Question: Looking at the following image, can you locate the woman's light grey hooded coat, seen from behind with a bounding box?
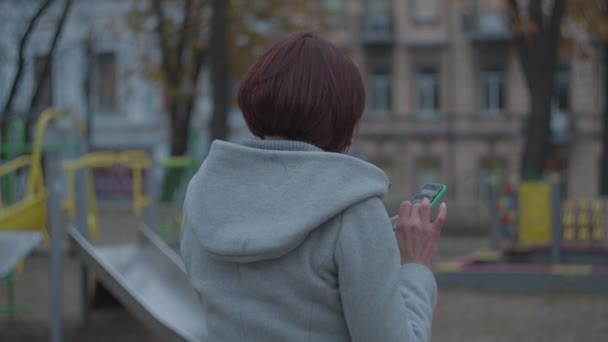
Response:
[181,139,437,342]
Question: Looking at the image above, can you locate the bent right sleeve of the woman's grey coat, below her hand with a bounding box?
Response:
[335,198,437,341]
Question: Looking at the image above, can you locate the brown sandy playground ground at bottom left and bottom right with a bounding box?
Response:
[0,204,608,342]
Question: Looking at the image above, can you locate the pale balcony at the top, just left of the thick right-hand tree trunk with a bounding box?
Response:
[462,2,513,43]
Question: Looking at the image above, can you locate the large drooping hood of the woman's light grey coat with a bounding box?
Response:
[183,139,388,262]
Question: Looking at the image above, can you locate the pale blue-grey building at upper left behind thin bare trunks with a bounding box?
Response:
[0,0,197,153]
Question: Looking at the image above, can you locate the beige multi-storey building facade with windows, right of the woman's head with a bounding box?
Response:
[328,0,603,210]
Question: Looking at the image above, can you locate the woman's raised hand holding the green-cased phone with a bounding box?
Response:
[391,198,448,267]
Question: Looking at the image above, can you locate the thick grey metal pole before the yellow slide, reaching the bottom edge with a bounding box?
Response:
[45,152,64,342]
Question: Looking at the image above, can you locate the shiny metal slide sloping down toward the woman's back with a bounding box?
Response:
[69,224,206,341]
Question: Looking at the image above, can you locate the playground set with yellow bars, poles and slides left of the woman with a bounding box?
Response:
[0,109,206,342]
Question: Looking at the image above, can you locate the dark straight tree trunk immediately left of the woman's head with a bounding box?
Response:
[210,0,230,142]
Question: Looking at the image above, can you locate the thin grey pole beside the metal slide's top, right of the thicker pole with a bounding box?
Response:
[75,168,91,324]
